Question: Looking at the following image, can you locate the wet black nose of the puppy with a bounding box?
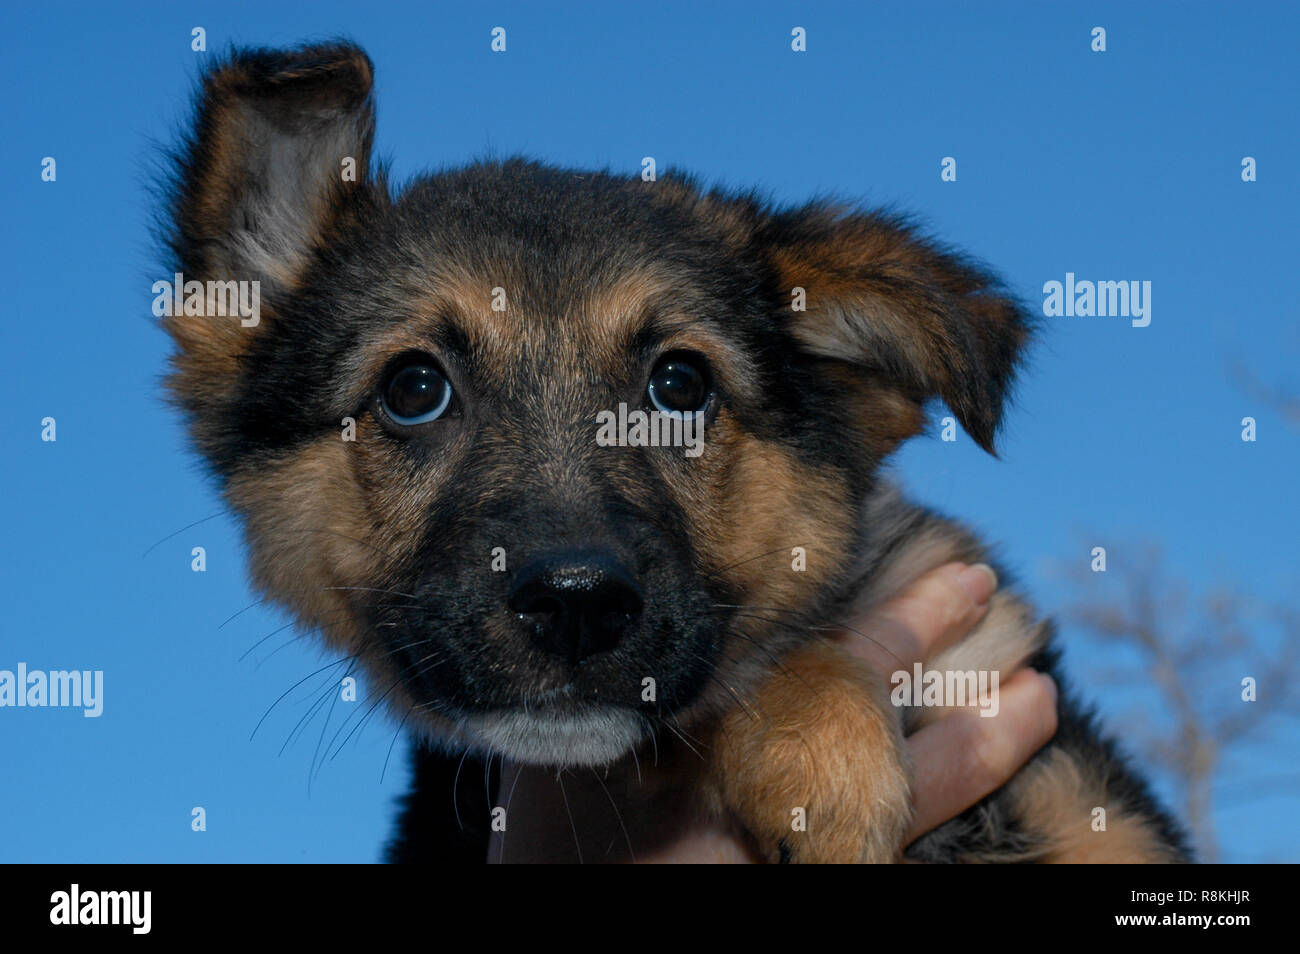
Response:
[506,550,644,663]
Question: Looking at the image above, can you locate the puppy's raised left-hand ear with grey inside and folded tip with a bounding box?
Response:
[164,43,374,409]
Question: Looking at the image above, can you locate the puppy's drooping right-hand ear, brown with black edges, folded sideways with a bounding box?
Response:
[759,204,1031,454]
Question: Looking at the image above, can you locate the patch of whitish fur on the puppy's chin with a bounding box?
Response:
[458,708,646,767]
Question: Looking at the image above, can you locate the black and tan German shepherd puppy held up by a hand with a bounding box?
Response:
[164,43,1187,862]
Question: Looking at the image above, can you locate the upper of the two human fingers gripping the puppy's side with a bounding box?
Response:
[836,563,997,675]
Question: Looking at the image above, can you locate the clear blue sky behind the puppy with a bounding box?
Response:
[0,0,1300,862]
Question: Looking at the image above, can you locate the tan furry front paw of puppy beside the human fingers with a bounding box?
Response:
[715,645,911,864]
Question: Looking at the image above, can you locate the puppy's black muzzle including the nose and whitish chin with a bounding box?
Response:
[379,561,729,767]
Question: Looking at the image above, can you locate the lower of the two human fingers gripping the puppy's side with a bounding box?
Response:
[907,669,1057,842]
